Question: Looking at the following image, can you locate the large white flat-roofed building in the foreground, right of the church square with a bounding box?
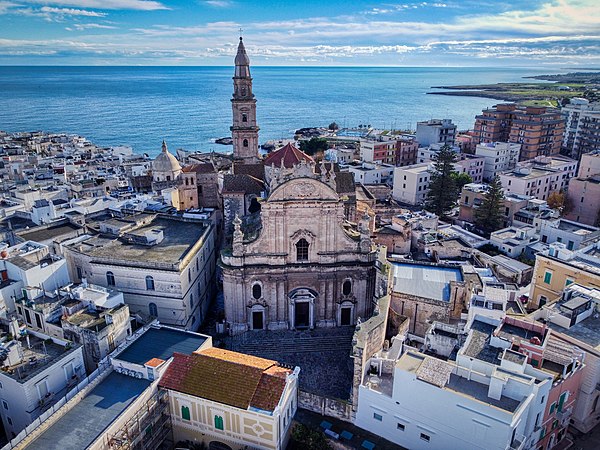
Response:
[355,351,539,450]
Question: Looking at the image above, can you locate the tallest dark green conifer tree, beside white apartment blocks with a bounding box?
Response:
[425,145,458,217]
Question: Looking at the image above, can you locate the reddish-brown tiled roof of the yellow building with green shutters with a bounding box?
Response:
[160,348,292,411]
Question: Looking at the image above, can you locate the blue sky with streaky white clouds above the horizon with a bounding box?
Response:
[0,0,600,68]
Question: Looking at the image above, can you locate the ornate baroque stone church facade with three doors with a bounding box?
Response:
[221,162,375,334]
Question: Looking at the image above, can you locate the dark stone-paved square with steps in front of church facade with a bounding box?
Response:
[222,327,354,400]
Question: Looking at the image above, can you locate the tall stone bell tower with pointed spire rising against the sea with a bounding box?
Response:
[231,36,260,164]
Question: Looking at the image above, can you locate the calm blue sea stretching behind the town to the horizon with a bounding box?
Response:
[0,67,552,156]
